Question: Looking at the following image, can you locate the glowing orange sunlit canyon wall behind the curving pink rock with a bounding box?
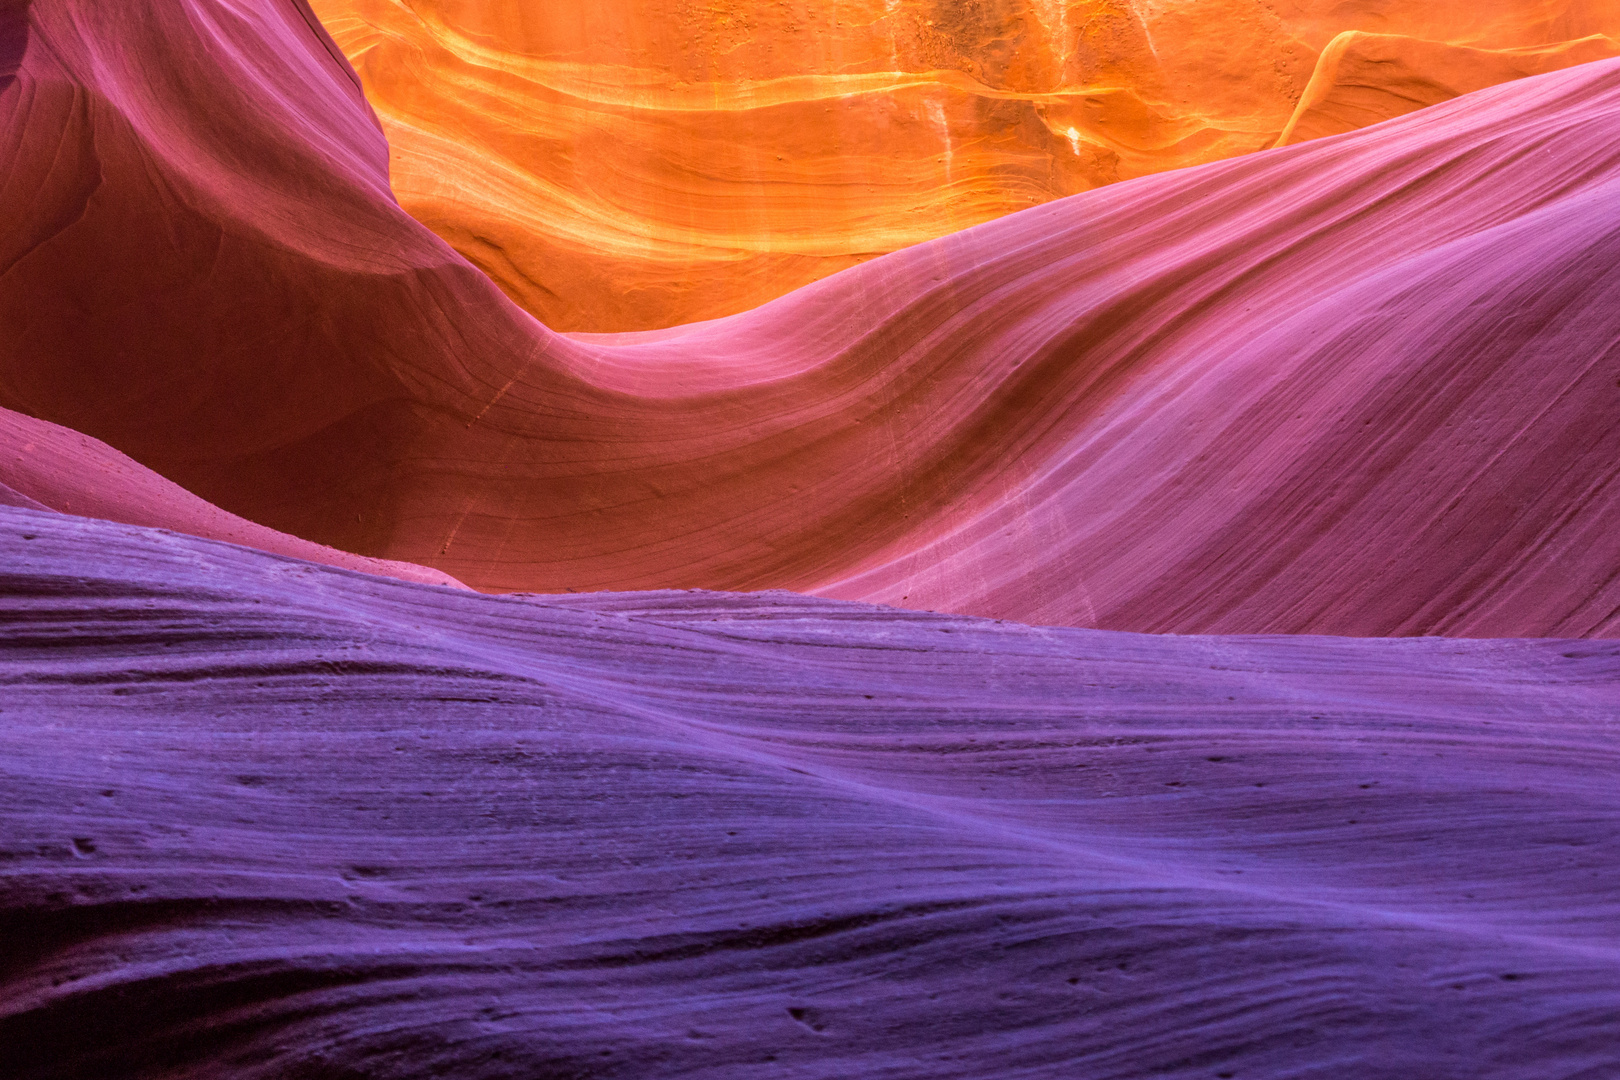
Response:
[313,0,1620,330]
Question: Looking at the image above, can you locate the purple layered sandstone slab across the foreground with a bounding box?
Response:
[0,508,1620,1080]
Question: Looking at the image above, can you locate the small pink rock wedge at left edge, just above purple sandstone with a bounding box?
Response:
[0,408,467,588]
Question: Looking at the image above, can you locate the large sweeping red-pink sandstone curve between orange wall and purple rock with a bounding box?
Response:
[0,0,1620,636]
